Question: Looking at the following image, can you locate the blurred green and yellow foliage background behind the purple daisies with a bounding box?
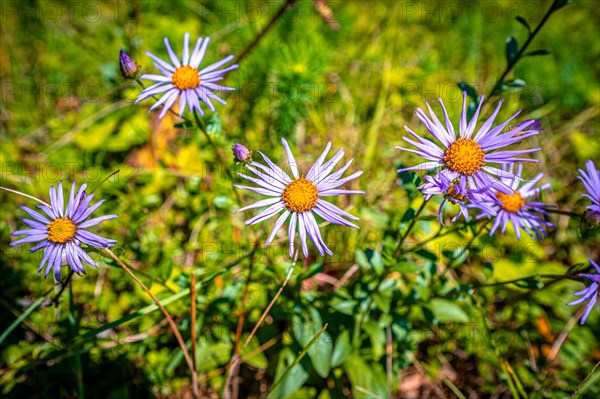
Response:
[0,0,600,399]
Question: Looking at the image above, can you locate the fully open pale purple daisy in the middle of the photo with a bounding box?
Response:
[236,138,365,257]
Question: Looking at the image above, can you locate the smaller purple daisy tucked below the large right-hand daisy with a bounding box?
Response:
[473,164,554,239]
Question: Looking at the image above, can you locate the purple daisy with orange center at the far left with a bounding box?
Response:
[10,182,117,281]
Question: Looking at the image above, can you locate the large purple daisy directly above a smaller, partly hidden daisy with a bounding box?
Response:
[396,92,540,194]
